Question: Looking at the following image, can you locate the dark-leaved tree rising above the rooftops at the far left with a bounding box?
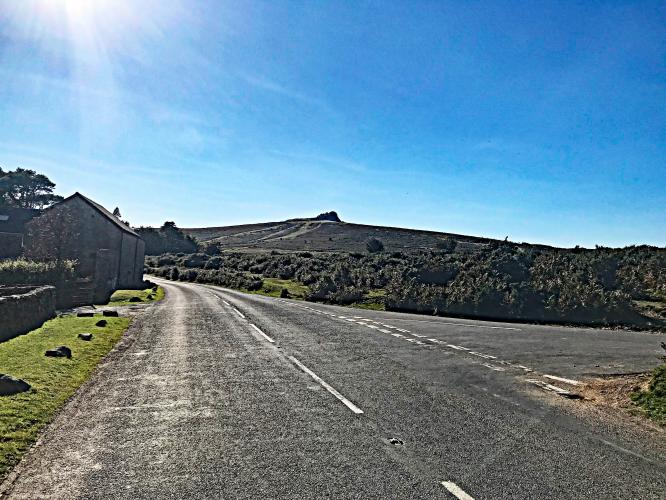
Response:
[0,168,63,209]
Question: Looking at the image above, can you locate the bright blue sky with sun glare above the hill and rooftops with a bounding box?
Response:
[0,0,666,246]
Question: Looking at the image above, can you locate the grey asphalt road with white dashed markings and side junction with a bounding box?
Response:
[0,281,666,500]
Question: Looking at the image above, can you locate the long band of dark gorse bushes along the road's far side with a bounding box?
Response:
[146,242,666,324]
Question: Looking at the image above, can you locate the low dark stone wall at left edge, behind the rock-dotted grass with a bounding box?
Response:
[0,286,56,342]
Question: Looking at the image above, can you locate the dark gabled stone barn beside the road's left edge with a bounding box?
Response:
[24,193,145,304]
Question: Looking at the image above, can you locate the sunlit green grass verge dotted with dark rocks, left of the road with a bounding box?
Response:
[0,316,130,476]
